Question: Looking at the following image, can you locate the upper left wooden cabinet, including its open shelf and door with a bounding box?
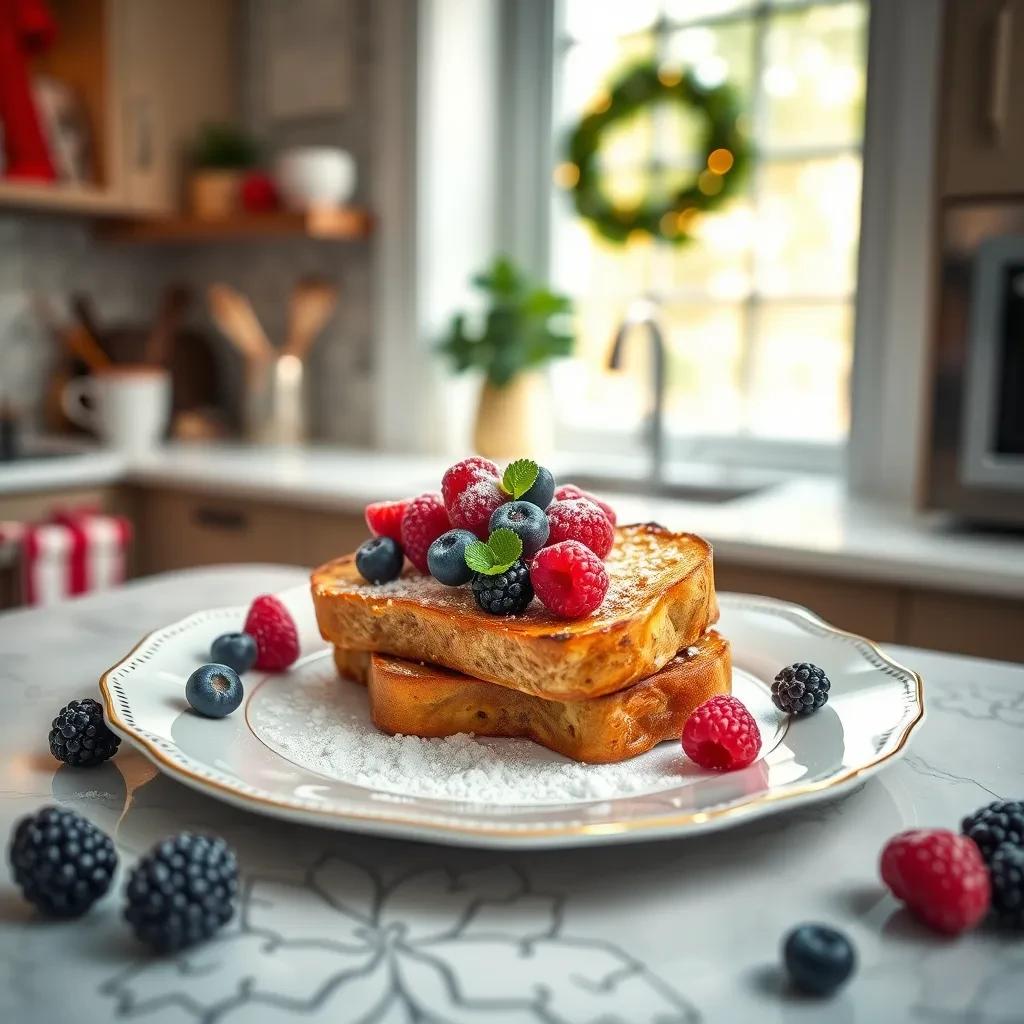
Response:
[0,0,238,216]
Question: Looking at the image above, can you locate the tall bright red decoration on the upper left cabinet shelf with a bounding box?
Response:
[0,0,57,181]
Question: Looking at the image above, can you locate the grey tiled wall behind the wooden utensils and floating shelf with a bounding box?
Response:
[0,0,378,445]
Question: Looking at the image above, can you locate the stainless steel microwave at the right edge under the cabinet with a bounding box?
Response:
[927,200,1024,526]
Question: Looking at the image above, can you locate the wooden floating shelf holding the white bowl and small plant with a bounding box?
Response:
[100,207,373,243]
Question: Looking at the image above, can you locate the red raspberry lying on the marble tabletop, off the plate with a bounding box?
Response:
[880,828,991,935]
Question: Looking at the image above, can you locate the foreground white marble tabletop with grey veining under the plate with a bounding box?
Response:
[0,566,1024,1024]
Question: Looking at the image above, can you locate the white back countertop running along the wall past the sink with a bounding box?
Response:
[0,445,1024,598]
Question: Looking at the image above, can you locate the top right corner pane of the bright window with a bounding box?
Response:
[762,3,866,150]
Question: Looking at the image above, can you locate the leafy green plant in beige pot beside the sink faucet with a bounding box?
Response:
[439,256,575,459]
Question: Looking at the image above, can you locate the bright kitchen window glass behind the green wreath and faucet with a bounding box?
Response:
[548,0,868,468]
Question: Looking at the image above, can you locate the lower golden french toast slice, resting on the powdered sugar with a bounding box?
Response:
[334,632,732,764]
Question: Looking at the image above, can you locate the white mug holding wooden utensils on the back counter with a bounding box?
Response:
[60,366,171,454]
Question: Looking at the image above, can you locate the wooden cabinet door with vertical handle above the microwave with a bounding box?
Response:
[939,0,1024,196]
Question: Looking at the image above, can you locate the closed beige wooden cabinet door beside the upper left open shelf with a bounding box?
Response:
[111,0,239,213]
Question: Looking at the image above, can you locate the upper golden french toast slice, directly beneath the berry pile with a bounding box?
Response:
[311,523,718,700]
